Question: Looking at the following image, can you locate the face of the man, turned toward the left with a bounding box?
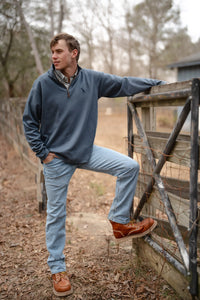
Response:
[51,40,77,71]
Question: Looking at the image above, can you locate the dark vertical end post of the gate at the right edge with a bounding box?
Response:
[189,79,200,296]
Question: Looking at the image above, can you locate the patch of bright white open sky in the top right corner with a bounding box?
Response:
[174,0,200,42]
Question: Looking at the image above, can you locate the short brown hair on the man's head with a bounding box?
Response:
[50,33,81,62]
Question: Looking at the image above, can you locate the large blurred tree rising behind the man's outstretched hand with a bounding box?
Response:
[127,0,180,77]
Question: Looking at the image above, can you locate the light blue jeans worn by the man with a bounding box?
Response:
[44,146,139,274]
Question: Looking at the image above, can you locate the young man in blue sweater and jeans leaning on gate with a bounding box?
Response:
[23,33,162,296]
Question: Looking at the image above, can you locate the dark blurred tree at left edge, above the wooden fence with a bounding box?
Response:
[0,0,33,97]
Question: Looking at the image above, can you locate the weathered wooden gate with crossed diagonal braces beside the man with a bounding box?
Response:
[127,78,200,299]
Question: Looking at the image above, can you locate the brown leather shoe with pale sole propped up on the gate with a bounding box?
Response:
[110,218,157,240]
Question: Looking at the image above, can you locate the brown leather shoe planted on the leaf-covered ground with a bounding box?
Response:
[52,272,73,297]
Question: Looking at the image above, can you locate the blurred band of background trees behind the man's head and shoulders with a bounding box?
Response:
[0,0,200,97]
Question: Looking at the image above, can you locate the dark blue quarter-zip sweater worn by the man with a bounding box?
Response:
[23,65,163,164]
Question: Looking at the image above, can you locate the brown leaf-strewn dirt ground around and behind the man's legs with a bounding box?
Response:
[0,105,180,300]
